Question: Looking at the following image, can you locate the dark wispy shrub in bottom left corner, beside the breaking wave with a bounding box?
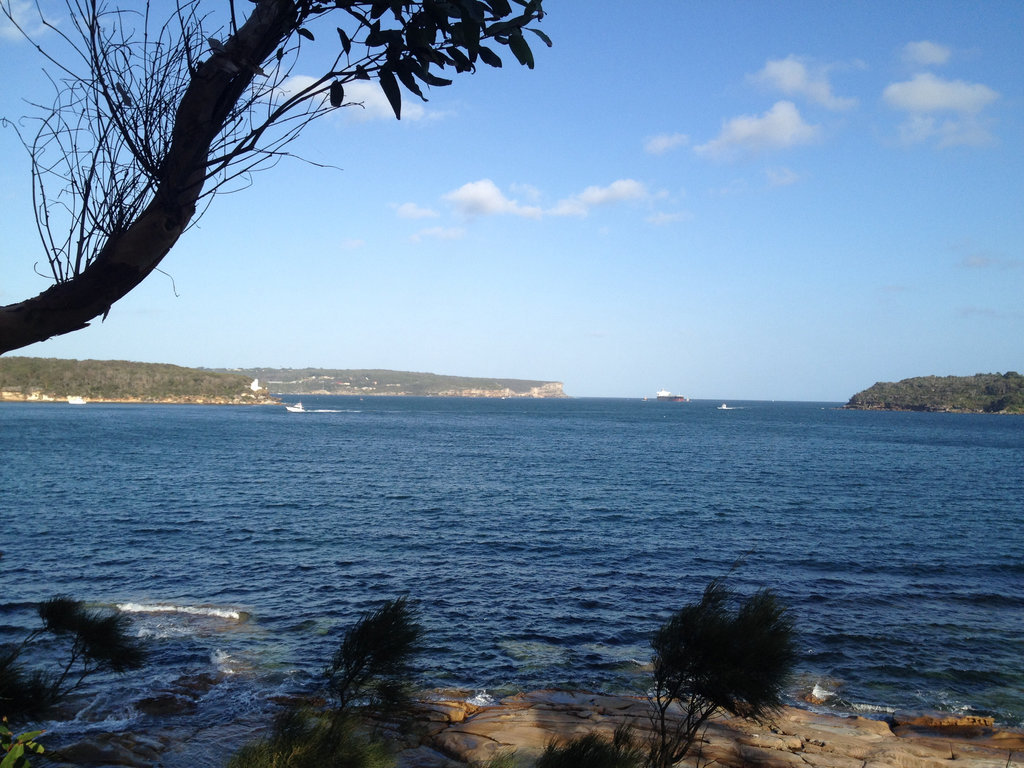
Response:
[0,595,144,721]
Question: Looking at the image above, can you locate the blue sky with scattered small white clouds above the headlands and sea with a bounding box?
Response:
[0,0,1024,400]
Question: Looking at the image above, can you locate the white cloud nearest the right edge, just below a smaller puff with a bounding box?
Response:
[882,72,999,147]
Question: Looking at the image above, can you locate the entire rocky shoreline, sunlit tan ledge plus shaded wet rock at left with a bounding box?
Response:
[44,690,1024,768]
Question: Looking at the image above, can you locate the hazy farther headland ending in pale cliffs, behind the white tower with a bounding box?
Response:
[215,368,566,397]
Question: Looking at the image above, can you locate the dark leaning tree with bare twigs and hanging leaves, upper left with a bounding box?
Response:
[0,0,551,353]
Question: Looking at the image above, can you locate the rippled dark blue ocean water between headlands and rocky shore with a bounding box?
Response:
[0,397,1024,753]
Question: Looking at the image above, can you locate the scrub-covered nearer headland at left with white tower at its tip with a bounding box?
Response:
[0,357,275,404]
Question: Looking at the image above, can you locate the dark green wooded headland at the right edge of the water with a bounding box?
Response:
[845,371,1024,414]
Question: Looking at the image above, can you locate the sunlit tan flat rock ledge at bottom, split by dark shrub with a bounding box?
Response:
[398,690,1024,768]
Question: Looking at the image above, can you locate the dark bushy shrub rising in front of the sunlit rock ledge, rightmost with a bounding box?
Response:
[649,580,796,768]
